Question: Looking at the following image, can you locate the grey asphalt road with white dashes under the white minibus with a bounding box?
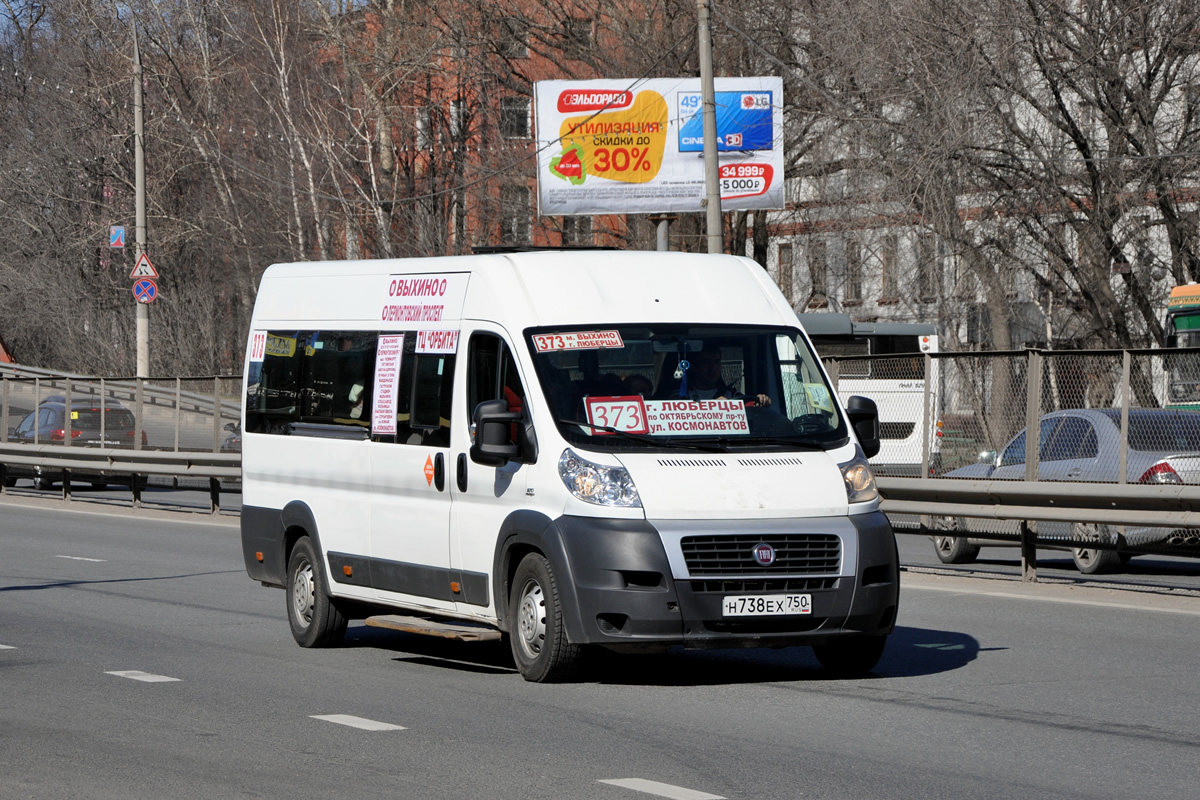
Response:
[0,498,1200,800]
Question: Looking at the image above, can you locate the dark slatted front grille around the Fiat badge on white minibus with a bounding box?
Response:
[679,534,841,577]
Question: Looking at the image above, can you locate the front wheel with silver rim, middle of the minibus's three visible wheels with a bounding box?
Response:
[509,553,580,682]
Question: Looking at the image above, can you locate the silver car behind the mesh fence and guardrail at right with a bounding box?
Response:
[932,409,1200,575]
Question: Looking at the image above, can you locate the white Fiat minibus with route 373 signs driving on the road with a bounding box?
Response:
[241,249,899,681]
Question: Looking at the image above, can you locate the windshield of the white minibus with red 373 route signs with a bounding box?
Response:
[526,324,848,451]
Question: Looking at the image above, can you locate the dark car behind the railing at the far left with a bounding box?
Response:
[5,395,148,489]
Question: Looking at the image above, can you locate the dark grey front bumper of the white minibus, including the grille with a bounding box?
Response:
[552,512,900,649]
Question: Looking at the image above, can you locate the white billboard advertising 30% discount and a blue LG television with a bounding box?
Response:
[534,77,784,216]
